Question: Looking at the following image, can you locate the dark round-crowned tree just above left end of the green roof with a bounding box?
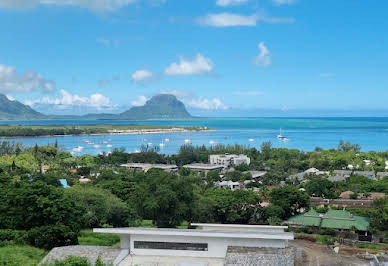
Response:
[269,186,310,219]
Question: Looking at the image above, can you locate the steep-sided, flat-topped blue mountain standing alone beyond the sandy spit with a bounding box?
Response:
[118,94,192,120]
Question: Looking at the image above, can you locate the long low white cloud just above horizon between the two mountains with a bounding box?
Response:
[24,90,113,110]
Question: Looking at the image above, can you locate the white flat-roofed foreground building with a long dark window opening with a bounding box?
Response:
[93,224,294,266]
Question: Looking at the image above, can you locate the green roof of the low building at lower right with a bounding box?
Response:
[287,209,370,231]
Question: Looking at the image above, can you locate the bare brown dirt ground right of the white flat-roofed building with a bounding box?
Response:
[289,240,370,266]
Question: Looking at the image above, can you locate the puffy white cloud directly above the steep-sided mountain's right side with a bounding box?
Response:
[164,54,214,76]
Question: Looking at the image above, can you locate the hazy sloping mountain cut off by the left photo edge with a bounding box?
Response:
[0,93,46,120]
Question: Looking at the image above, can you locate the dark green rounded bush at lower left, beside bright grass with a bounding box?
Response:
[28,224,78,250]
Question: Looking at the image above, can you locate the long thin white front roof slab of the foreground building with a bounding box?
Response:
[93,227,294,240]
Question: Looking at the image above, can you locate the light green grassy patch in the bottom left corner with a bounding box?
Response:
[0,245,47,266]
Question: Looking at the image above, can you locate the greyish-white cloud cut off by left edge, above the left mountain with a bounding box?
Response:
[0,64,55,93]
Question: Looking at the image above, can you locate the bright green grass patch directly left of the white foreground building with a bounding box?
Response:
[78,229,120,247]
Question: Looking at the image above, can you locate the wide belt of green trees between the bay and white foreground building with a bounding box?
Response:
[0,139,388,264]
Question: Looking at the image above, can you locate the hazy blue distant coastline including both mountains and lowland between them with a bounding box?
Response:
[0,94,192,120]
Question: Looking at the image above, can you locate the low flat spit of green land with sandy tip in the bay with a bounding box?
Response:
[0,125,211,137]
